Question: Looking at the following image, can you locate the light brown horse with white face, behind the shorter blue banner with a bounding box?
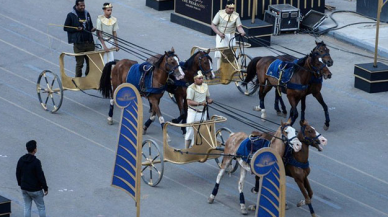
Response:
[208,122,302,215]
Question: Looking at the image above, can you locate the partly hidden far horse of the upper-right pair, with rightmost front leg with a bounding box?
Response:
[275,54,332,130]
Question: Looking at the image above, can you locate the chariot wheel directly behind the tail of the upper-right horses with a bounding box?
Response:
[234,54,259,96]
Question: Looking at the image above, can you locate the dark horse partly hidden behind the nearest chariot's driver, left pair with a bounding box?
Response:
[147,49,215,134]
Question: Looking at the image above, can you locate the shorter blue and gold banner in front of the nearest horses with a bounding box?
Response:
[251,148,286,217]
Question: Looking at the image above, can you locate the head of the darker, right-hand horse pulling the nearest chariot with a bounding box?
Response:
[300,121,327,151]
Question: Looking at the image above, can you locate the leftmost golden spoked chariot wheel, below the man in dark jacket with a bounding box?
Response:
[36,70,63,113]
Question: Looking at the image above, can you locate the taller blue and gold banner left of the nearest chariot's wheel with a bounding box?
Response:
[112,83,143,215]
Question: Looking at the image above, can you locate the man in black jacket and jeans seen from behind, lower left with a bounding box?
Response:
[16,140,48,217]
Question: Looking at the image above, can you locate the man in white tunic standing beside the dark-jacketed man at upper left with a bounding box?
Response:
[96,3,119,63]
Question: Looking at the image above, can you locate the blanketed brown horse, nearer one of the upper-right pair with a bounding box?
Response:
[243,42,333,124]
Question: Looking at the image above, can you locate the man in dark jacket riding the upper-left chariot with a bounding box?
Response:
[63,0,96,77]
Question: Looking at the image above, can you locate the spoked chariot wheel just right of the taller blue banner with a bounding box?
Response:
[141,139,164,187]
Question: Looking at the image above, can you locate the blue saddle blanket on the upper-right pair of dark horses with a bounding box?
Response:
[266,59,298,84]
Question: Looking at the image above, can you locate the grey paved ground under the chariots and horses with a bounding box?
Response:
[0,0,388,217]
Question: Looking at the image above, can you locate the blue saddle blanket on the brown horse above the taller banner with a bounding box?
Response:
[127,62,166,93]
